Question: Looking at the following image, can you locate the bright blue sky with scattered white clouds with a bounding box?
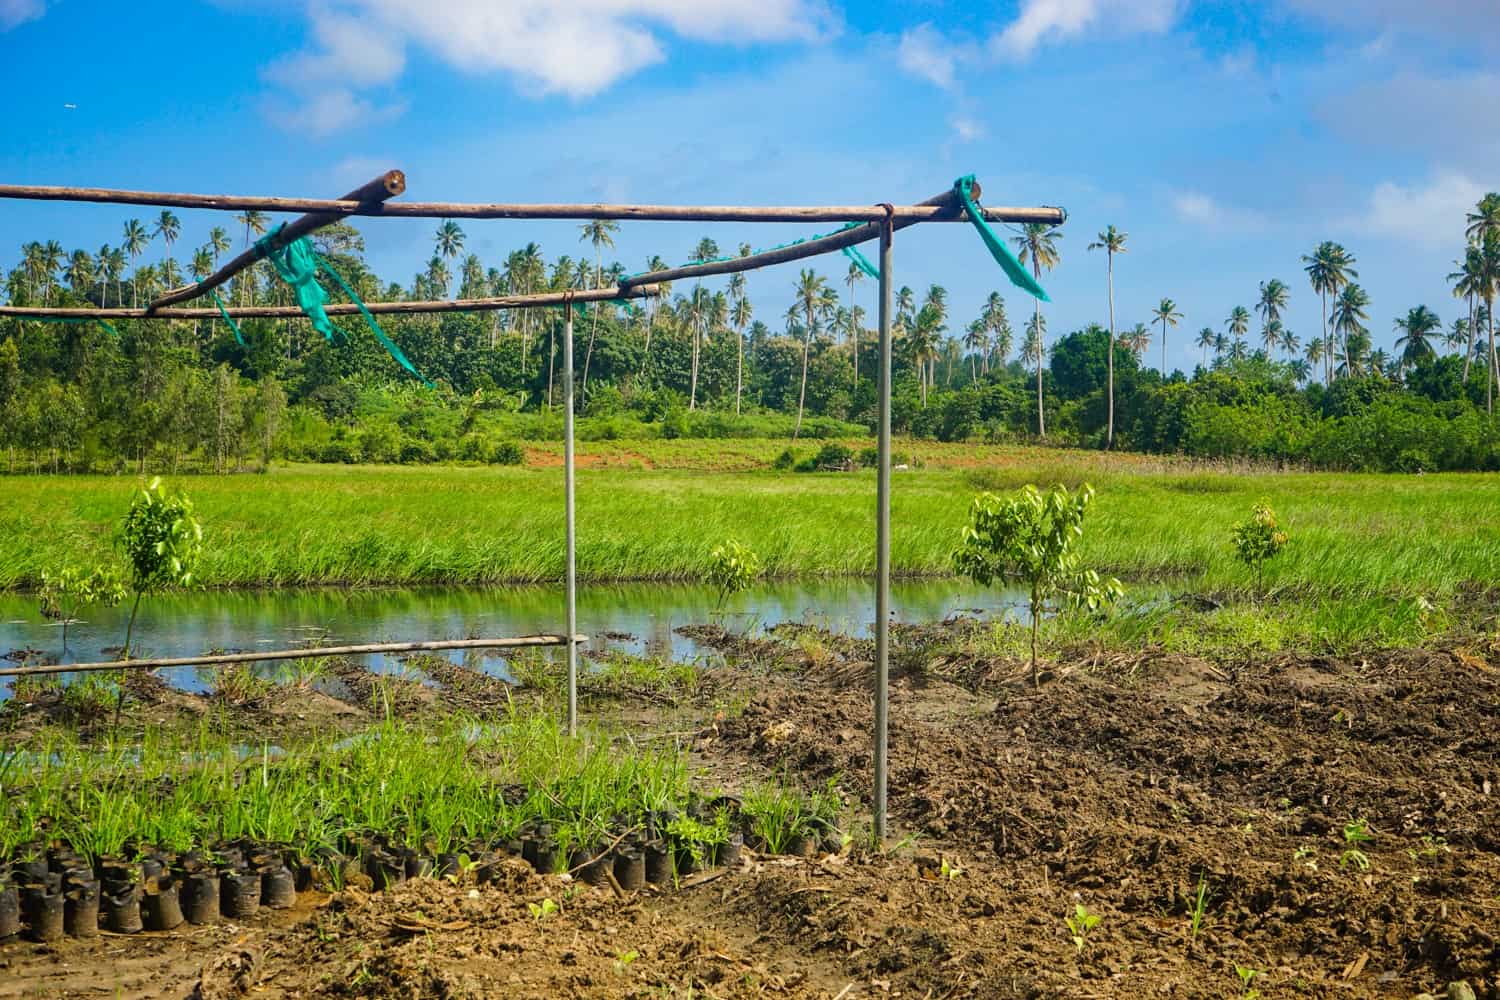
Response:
[0,0,1500,366]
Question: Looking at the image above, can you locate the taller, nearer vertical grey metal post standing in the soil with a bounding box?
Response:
[875,212,896,846]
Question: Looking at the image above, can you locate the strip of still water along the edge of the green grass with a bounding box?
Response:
[0,579,1023,699]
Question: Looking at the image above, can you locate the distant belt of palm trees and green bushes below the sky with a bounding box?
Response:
[0,195,1500,472]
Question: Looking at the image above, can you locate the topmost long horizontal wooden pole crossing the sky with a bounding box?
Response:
[0,184,1068,225]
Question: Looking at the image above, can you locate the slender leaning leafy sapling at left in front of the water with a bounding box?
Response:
[119,477,203,660]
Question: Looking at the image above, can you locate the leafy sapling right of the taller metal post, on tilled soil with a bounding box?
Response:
[953,484,1124,685]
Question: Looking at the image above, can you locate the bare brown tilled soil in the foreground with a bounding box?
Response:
[0,622,1500,1000]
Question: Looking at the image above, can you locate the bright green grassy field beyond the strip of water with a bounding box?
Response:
[0,442,1500,597]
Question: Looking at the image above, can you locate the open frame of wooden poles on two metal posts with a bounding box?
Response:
[0,169,1068,840]
